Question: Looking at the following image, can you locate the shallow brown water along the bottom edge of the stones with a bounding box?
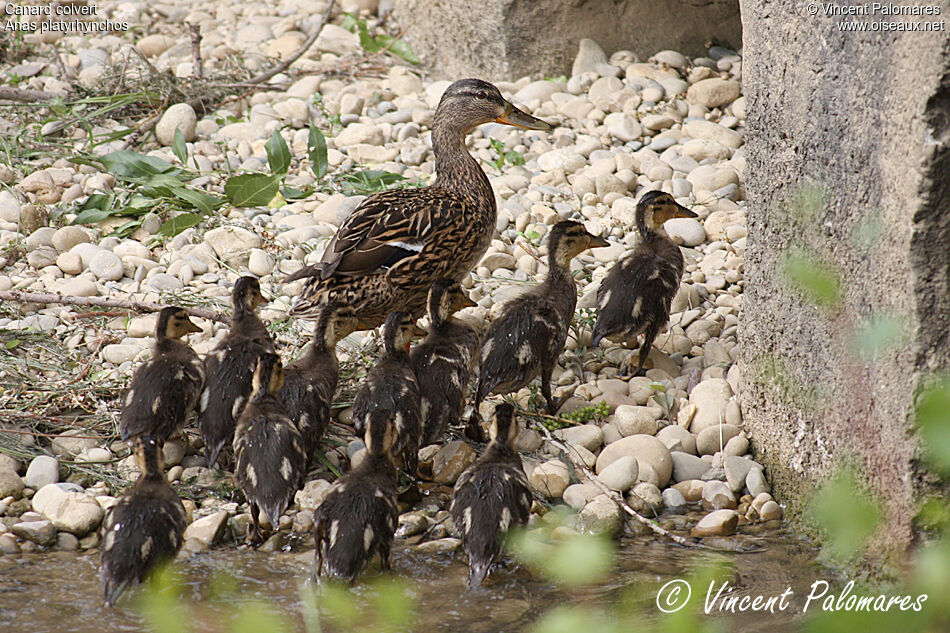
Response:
[0,530,832,633]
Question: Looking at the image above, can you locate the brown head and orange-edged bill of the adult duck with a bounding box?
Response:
[433,79,554,134]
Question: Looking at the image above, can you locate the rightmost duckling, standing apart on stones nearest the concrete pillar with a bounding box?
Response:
[591,191,696,376]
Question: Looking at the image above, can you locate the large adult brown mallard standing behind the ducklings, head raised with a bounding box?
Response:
[288,79,552,329]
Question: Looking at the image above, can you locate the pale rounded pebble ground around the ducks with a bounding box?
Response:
[0,0,781,554]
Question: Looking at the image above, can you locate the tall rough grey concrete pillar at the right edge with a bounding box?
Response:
[740,0,950,558]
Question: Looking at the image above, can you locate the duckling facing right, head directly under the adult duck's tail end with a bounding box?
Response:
[277,304,357,458]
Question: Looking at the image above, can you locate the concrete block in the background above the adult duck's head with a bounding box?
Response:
[395,0,741,80]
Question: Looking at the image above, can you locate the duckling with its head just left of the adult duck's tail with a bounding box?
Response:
[198,277,274,468]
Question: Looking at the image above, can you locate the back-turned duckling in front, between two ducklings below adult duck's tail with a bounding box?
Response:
[234,354,307,543]
